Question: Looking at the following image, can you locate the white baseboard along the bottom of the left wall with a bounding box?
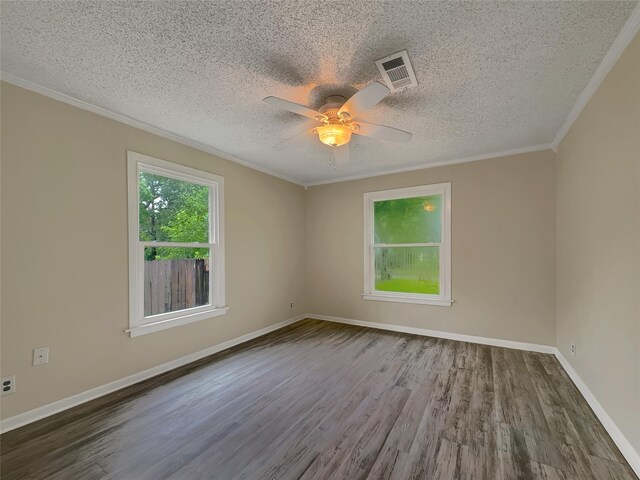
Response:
[0,315,306,433]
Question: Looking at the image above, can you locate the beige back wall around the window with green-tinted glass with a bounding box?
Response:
[307,150,555,345]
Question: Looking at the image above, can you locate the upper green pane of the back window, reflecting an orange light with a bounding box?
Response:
[373,195,442,244]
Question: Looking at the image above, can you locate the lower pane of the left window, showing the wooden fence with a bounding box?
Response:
[144,247,210,317]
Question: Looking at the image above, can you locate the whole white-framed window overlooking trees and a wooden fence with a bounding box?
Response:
[127,152,227,337]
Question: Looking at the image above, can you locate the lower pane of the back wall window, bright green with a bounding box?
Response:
[375,247,440,295]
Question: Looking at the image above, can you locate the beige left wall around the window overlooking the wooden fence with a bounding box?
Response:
[1,83,305,418]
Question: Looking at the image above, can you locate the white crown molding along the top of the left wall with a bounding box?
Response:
[0,72,305,186]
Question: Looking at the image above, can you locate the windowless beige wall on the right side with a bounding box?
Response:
[557,31,640,452]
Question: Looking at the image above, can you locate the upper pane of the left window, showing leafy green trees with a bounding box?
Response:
[138,172,209,243]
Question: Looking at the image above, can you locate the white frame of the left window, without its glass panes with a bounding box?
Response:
[126,151,228,337]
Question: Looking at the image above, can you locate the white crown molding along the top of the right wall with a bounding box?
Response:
[551,3,640,151]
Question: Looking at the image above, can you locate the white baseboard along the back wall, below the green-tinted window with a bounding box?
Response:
[307,313,556,353]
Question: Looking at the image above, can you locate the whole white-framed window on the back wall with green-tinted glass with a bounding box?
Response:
[363,183,451,305]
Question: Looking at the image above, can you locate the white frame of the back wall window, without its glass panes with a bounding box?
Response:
[362,182,453,306]
